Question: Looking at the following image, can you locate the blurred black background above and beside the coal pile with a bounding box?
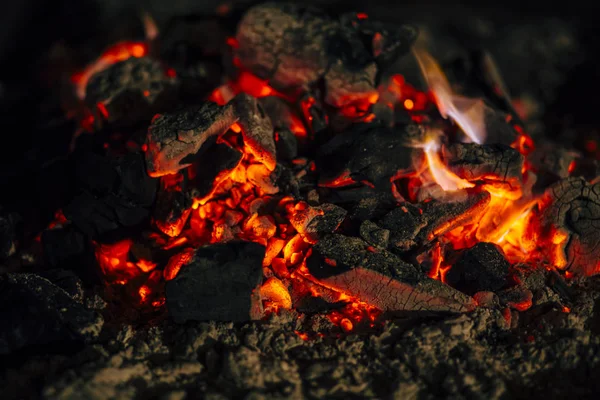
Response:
[0,0,600,225]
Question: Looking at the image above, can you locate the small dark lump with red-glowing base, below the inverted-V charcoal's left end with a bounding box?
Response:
[152,187,193,237]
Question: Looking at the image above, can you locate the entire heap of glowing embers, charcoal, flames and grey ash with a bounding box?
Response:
[0,3,600,399]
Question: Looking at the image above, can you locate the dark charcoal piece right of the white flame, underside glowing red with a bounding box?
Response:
[443,143,525,190]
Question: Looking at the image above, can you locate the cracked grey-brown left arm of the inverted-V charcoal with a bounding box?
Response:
[146,102,237,177]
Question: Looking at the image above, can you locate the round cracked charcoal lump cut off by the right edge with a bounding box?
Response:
[539,178,600,276]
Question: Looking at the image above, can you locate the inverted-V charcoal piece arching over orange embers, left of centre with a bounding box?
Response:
[146,94,276,177]
